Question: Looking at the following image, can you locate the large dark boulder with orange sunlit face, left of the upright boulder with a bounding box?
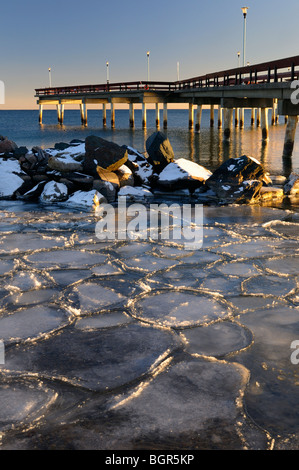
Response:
[83,135,128,175]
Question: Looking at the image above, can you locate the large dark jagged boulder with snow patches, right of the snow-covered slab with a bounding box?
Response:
[206,155,271,193]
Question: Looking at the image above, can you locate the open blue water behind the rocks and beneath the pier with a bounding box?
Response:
[0,109,299,176]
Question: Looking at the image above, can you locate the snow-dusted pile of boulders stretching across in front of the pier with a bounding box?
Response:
[0,132,299,207]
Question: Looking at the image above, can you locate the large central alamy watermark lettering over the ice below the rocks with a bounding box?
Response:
[95,197,203,250]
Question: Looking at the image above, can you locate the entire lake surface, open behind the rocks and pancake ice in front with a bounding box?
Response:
[0,110,299,451]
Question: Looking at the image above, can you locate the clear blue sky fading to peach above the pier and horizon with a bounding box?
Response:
[0,0,299,109]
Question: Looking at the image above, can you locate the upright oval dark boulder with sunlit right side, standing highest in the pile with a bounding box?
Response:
[146,131,174,173]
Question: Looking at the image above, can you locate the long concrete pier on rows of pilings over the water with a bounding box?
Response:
[35,56,299,157]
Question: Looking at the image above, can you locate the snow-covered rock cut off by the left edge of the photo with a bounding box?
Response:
[0,158,24,199]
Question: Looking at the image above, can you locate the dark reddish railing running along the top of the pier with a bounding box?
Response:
[35,56,299,97]
